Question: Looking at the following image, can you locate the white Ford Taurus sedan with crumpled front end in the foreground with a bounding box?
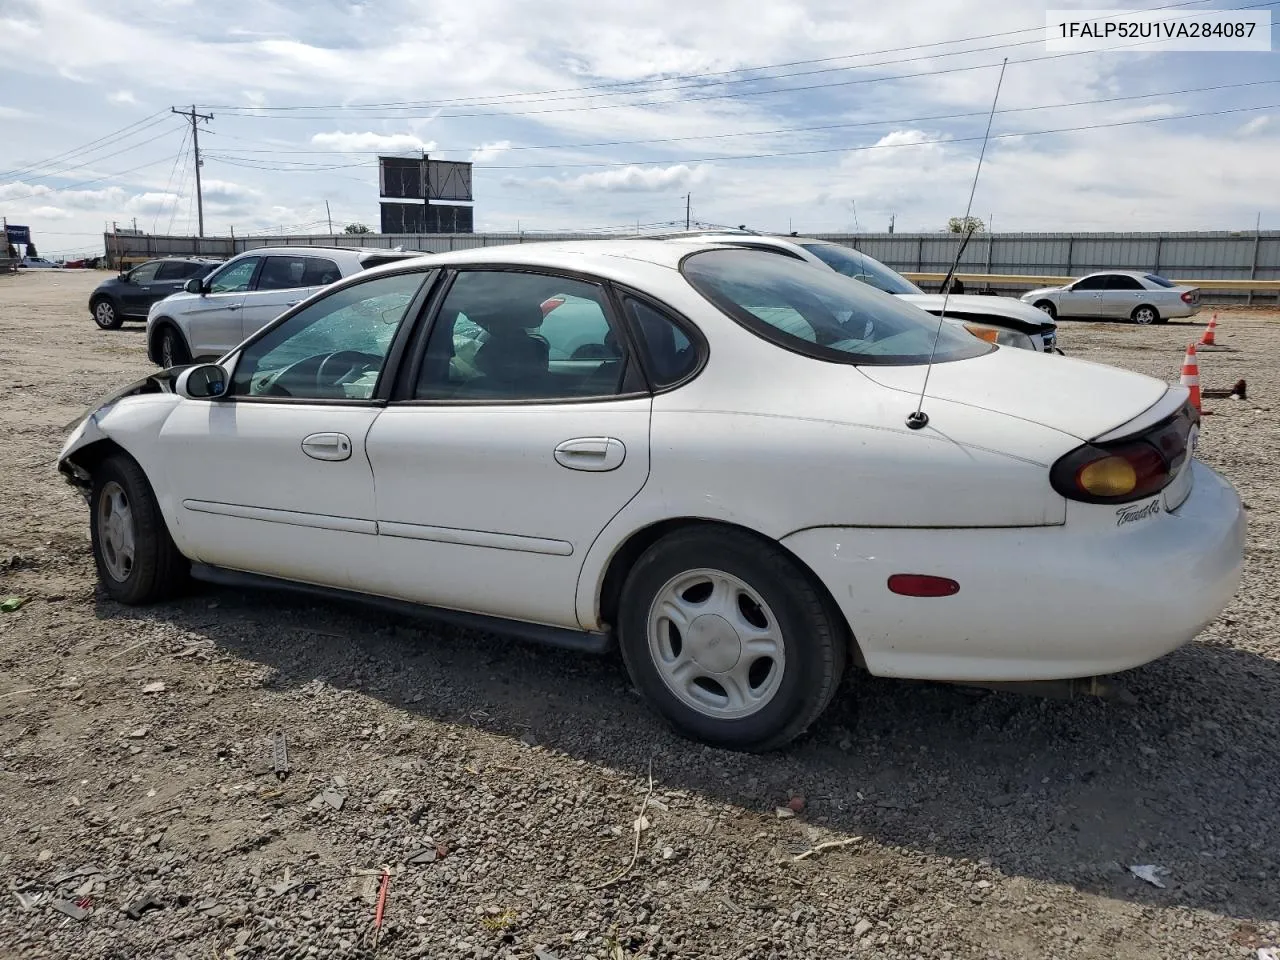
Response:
[59,239,1244,750]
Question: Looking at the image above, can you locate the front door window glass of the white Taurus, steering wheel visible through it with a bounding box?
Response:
[230,273,428,399]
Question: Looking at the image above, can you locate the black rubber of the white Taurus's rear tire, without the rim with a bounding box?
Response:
[618,529,850,753]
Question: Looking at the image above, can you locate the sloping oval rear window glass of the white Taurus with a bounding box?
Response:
[680,250,993,366]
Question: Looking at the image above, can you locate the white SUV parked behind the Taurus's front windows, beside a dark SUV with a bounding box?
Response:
[147,247,420,367]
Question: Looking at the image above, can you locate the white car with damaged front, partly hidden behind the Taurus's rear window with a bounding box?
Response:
[671,233,1061,353]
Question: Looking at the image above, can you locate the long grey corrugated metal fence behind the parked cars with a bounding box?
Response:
[104,230,1280,298]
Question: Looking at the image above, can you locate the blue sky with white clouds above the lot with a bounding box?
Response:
[0,0,1280,255]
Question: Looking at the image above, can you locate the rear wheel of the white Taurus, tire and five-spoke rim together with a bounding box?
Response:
[618,529,847,751]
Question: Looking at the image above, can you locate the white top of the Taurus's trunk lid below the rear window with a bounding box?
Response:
[858,347,1169,440]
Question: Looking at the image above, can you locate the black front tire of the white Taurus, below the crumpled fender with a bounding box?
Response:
[90,453,191,605]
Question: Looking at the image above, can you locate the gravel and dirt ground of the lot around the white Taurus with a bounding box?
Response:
[0,273,1280,960]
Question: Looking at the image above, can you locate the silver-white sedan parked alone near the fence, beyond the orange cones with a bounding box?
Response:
[1021,270,1201,325]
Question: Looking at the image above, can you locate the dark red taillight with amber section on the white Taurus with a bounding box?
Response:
[1048,406,1197,503]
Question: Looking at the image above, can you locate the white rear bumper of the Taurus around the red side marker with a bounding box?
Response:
[783,462,1244,681]
